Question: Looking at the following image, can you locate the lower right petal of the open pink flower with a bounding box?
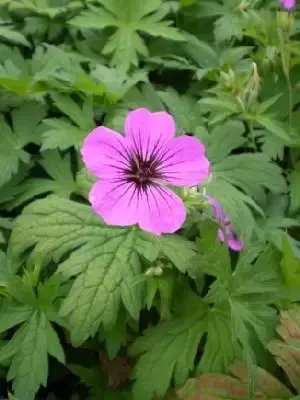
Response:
[139,186,186,235]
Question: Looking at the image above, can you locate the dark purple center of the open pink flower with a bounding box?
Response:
[126,155,161,187]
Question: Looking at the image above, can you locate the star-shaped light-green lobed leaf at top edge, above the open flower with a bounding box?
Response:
[70,0,185,71]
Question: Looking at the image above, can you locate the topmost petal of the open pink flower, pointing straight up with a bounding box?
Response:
[125,108,176,159]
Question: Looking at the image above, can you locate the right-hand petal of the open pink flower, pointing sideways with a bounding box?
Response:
[159,136,210,186]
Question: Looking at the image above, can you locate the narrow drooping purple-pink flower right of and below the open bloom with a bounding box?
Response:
[207,196,244,251]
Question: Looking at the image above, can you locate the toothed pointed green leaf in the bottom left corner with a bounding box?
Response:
[0,311,64,400]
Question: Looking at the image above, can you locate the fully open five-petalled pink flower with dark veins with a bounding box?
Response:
[81,108,210,235]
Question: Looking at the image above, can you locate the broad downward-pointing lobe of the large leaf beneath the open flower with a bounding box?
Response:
[58,230,142,343]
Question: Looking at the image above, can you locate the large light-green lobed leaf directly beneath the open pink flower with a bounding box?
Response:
[10,196,142,343]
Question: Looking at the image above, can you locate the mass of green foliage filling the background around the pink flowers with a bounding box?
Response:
[0,0,300,400]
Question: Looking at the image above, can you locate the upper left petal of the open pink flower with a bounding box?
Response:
[81,126,129,178]
